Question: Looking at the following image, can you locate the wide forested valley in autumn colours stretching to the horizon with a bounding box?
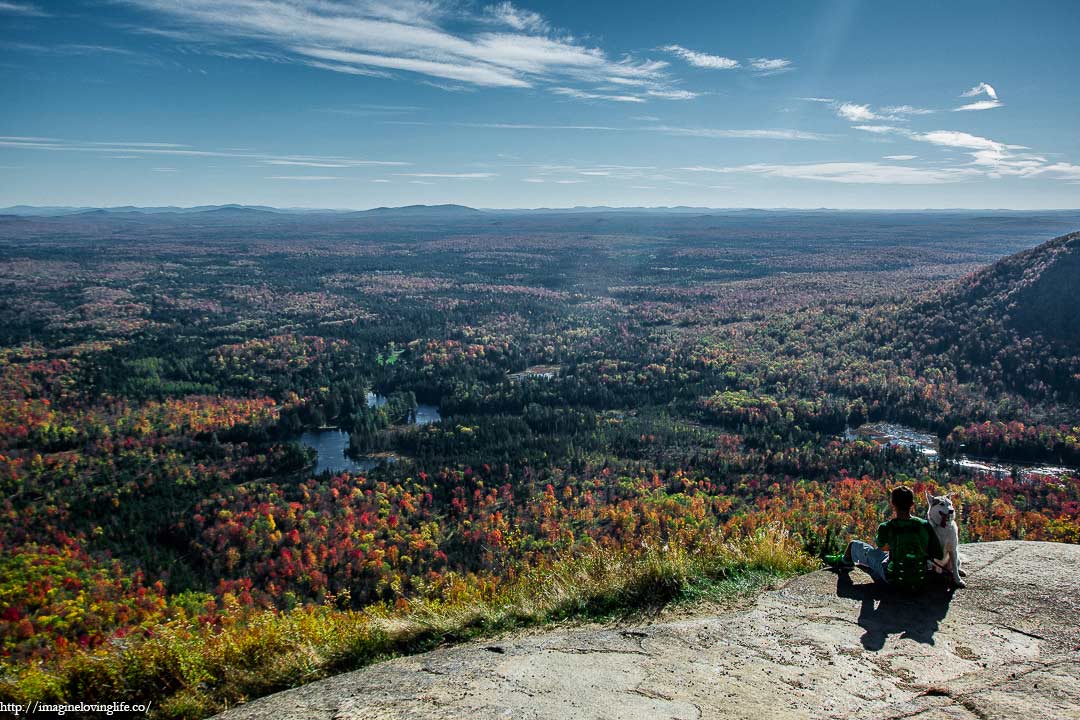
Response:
[0,208,1080,718]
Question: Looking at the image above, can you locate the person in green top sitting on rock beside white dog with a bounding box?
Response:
[825,487,945,589]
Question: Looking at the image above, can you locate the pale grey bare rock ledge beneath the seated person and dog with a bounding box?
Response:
[218,542,1080,720]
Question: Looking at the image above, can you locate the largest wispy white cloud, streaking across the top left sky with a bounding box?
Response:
[118,0,678,101]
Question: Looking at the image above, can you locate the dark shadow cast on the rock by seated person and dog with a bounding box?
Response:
[836,571,953,651]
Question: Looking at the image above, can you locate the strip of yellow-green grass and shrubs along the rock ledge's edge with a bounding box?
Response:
[0,526,819,720]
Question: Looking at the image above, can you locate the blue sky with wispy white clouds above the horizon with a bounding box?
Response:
[0,0,1080,208]
